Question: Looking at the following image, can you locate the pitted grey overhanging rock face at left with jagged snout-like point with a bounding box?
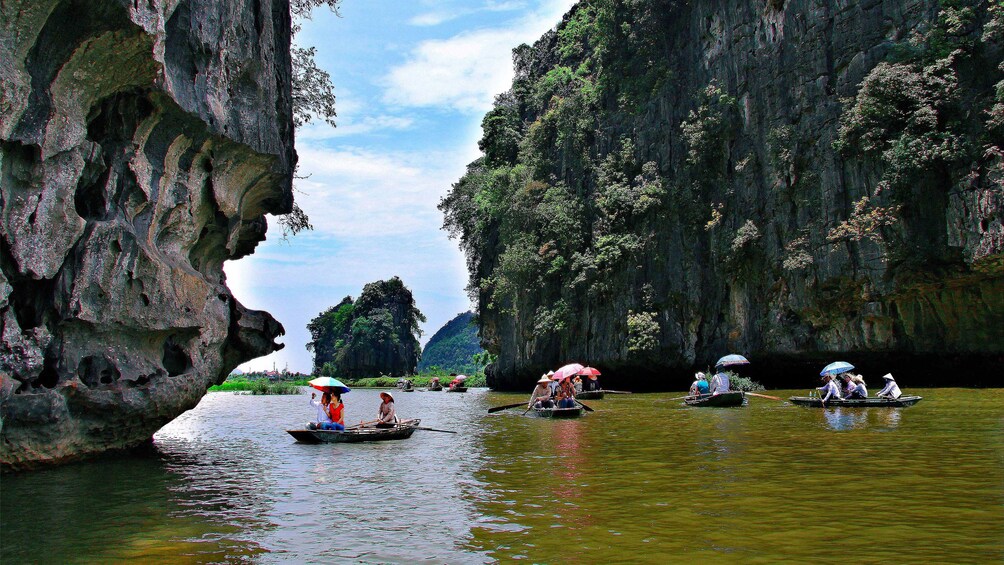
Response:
[0,0,295,469]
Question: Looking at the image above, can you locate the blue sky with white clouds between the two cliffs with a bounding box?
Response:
[225,0,574,372]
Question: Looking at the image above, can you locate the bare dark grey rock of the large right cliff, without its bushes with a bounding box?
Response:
[467,0,1004,389]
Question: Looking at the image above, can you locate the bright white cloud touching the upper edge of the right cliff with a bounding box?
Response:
[384,0,575,113]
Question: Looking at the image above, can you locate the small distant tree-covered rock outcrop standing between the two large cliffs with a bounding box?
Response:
[307,277,426,378]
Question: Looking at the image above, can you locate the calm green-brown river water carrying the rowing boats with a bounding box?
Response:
[0,388,1004,563]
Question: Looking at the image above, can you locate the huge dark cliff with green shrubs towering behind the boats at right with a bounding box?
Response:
[441,0,1004,388]
